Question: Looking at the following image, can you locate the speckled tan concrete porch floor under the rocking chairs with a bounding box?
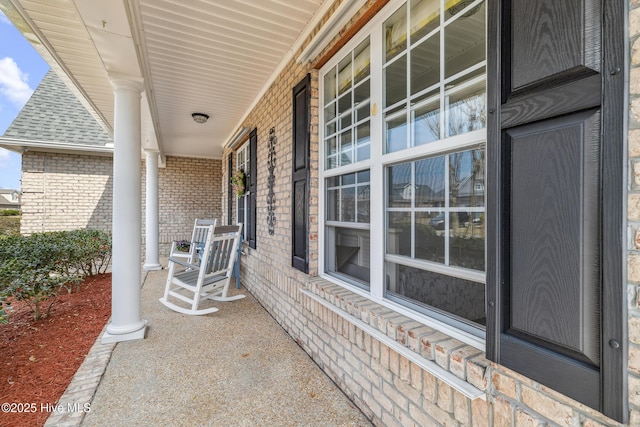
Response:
[46,270,371,426]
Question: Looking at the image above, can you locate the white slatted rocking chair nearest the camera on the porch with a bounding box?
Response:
[160,224,245,315]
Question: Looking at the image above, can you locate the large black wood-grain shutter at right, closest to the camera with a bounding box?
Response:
[487,0,628,422]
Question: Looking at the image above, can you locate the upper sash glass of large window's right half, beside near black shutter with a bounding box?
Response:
[383,0,486,153]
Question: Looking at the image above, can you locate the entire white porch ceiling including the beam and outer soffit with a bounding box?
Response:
[5,0,336,158]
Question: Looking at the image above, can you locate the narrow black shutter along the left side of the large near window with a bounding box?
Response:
[291,74,311,273]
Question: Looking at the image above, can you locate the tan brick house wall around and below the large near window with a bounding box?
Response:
[223,0,640,427]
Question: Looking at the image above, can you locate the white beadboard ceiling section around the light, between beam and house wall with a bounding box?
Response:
[130,0,323,158]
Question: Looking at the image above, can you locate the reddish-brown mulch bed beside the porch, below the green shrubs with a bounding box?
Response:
[0,274,111,427]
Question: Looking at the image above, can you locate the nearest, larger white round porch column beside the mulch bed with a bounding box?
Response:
[102,75,147,343]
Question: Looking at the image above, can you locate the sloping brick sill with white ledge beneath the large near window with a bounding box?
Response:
[301,278,490,400]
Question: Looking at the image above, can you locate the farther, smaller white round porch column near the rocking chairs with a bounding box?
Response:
[143,150,162,271]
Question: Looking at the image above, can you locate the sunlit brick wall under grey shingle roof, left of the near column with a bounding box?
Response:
[20,151,113,234]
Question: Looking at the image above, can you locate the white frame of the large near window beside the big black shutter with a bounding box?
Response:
[318,0,487,351]
